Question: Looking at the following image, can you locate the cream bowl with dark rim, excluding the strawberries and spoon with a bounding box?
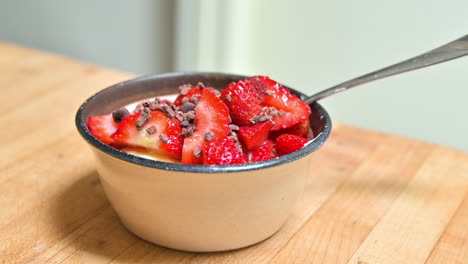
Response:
[76,73,331,252]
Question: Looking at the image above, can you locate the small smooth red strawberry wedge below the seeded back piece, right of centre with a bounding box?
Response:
[239,121,273,150]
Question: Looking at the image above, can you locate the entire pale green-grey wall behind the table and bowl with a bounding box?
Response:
[0,0,468,151]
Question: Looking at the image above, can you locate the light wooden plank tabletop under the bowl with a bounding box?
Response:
[0,43,468,264]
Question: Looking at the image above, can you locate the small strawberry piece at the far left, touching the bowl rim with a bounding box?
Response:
[87,114,118,146]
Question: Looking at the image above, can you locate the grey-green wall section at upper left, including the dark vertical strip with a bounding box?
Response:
[0,0,174,74]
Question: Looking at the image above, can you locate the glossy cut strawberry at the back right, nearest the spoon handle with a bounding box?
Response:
[258,76,311,130]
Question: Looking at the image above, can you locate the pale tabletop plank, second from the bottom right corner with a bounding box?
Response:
[348,147,468,264]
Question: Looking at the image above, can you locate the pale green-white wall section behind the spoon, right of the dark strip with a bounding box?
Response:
[178,0,468,150]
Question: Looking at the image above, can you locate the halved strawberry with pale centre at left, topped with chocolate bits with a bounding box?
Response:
[112,111,182,159]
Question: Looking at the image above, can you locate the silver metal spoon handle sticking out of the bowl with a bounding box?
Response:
[304,35,468,104]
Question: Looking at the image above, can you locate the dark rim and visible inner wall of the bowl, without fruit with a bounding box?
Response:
[75,73,331,172]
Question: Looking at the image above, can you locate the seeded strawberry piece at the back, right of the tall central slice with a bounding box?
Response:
[221,77,266,126]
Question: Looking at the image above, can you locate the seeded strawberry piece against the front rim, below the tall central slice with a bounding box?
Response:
[203,138,247,165]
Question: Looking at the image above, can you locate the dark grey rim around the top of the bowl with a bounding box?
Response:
[75,72,332,173]
